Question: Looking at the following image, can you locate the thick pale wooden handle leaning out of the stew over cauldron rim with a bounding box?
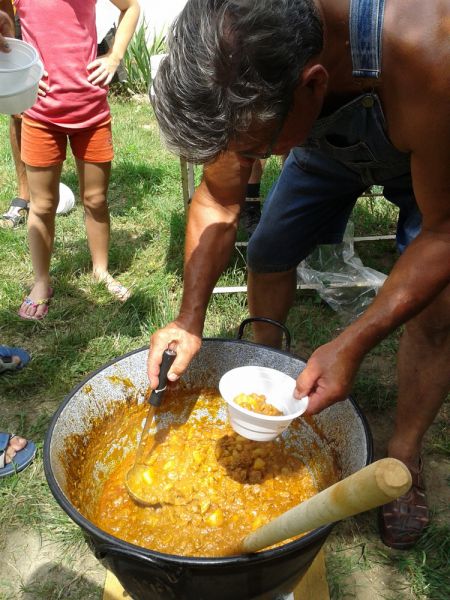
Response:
[240,458,412,552]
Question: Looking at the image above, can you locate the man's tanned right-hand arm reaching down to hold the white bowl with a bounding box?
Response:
[296,69,450,413]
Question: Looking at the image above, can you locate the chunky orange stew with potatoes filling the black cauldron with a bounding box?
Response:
[65,386,337,557]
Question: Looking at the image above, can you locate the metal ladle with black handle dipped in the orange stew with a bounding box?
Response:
[125,348,177,505]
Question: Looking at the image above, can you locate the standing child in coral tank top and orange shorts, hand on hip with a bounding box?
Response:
[14,0,140,320]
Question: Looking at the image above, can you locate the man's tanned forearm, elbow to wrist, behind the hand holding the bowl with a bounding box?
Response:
[339,233,450,359]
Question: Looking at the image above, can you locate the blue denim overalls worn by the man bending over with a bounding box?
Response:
[247,0,421,272]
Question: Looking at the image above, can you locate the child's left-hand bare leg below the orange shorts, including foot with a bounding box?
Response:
[22,163,62,316]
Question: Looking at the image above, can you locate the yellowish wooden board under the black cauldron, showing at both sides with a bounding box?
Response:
[103,550,330,600]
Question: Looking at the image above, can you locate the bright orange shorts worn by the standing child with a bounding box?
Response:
[21,115,114,167]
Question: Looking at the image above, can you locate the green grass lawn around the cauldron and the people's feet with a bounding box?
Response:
[0,98,449,600]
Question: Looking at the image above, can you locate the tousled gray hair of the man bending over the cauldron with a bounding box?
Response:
[152,0,323,163]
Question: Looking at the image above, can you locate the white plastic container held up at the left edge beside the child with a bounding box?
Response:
[0,38,44,115]
